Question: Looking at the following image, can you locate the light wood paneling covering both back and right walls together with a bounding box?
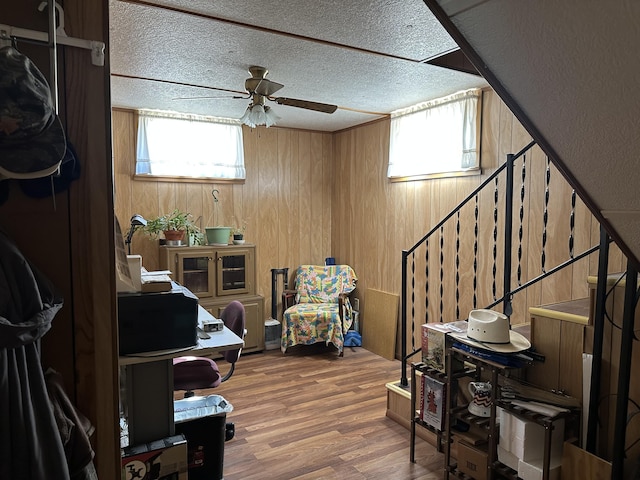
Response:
[113,91,622,352]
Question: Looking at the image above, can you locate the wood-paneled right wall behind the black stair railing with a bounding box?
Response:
[332,91,623,351]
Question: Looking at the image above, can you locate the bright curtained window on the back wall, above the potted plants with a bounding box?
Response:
[136,110,245,179]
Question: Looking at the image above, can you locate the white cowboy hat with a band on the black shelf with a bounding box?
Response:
[451,309,531,353]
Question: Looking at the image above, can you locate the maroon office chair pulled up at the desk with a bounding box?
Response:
[173,300,246,398]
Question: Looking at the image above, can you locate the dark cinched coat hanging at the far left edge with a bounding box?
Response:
[0,231,69,480]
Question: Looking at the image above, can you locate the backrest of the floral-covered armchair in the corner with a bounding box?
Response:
[295,265,358,303]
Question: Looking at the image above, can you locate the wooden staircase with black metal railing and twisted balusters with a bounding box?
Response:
[387,142,640,476]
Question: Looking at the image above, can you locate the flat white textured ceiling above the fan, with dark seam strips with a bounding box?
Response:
[109,0,487,131]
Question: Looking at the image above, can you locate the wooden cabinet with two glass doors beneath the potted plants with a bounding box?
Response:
[160,244,264,352]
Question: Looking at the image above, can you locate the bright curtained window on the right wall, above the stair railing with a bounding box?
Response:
[387,89,482,181]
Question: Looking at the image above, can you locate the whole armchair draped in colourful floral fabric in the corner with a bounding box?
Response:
[281,265,358,356]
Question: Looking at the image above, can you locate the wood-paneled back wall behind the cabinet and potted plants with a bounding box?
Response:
[113,109,335,316]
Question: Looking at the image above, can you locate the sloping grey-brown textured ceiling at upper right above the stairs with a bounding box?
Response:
[426,0,640,263]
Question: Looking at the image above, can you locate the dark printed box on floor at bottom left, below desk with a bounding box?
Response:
[122,435,187,480]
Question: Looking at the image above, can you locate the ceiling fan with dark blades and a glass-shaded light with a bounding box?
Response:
[176,66,338,127]
